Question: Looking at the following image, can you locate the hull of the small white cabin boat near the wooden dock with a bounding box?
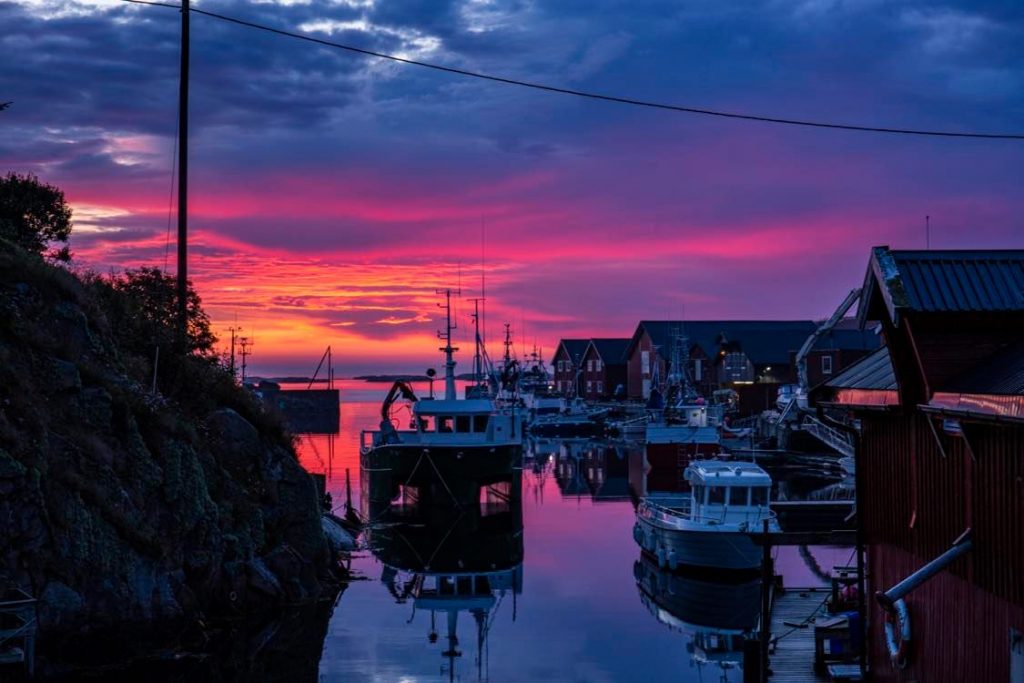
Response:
[634,518,762,571]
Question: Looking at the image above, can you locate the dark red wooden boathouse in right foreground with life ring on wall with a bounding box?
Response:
[812,247,1024,682]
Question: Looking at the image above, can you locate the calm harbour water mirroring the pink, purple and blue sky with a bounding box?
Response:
[300,381,850,682]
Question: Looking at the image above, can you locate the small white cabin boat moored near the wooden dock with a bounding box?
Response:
[633,460,780,570]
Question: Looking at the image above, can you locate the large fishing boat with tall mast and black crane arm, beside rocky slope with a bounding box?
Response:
[359,291,522,502]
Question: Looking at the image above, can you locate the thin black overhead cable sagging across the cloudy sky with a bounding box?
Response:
[121,0,1024,140]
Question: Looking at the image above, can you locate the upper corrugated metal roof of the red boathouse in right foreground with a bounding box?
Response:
[877,250,1024,312]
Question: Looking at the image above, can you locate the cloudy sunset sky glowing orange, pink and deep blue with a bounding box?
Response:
[0,0,1024,375]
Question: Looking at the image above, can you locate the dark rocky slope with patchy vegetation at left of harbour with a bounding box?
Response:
[0,250,332,663]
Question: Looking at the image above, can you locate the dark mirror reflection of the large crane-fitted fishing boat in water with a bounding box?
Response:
[362,469,523,681]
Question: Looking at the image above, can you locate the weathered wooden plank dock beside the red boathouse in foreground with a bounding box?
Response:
[769,588,830,683]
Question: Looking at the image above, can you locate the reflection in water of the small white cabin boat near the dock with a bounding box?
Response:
[633,554,761,683]
